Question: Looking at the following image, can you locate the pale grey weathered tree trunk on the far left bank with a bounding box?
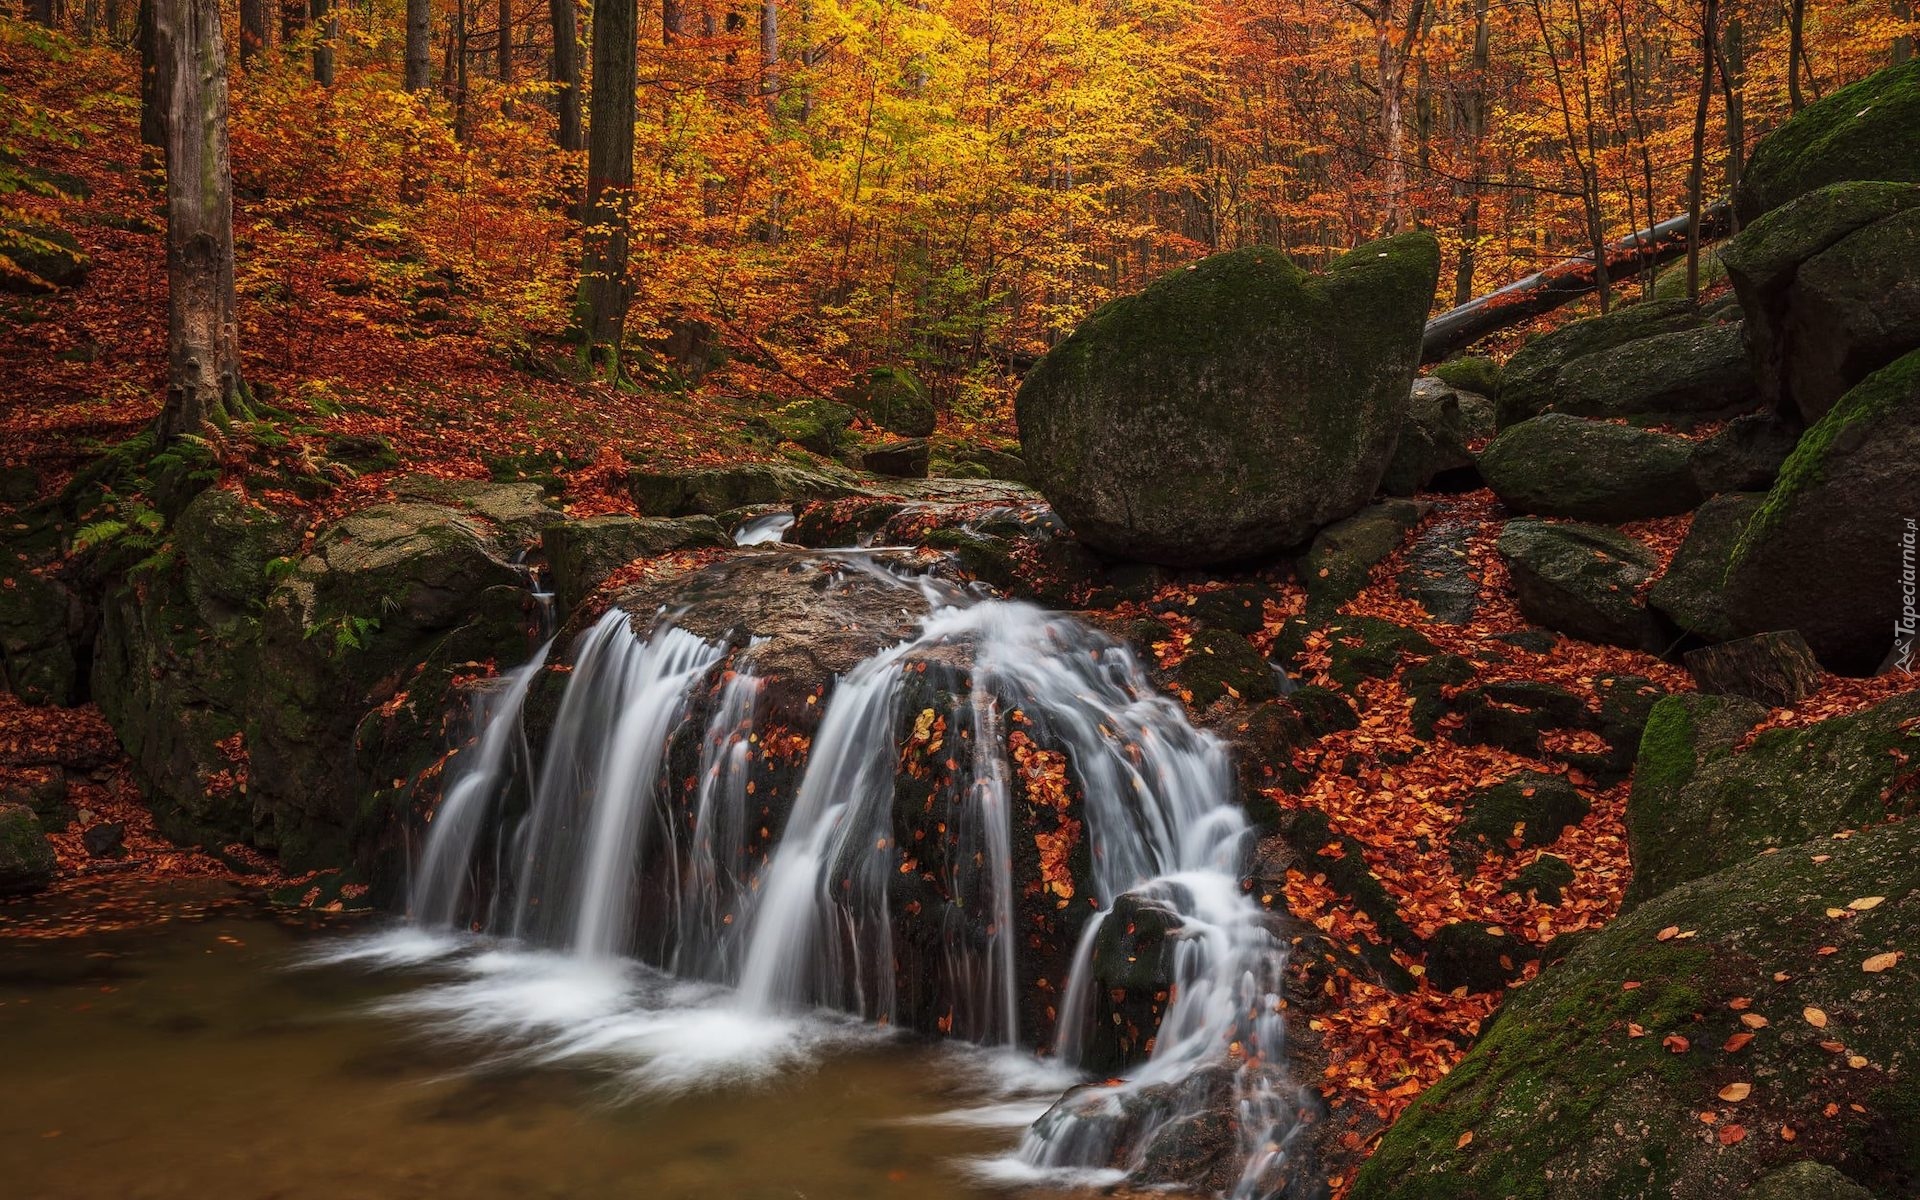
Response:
[152,0,248,442]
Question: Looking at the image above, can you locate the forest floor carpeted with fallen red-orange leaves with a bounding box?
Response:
[0,21,1899,1194]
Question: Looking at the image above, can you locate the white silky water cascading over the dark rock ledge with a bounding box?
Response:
[395,551,1292,1196]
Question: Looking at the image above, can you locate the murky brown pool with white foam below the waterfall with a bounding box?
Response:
[0,881,1113,1200]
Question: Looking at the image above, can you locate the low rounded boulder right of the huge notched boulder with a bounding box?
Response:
[1480,413,1699,522]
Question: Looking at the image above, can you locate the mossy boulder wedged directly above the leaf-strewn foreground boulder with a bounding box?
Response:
[1626,693,1920,904]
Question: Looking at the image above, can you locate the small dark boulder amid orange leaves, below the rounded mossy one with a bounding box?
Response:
[1496,518,1668,653]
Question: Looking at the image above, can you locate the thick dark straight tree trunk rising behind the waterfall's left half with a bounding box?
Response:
[578,0,639,364]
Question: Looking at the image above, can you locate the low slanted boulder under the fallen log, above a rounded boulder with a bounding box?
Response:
[1546,323,1759,426]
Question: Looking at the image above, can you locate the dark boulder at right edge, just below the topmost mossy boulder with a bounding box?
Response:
[1722,180,1920,424]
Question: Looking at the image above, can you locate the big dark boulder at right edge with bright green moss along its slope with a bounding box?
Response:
[1724,351,1920,674]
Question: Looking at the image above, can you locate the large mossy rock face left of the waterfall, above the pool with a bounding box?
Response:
[92,480,559,881]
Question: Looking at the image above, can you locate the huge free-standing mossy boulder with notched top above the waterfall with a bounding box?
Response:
[1016,234,1440,566]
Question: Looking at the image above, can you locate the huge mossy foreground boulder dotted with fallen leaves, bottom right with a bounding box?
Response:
[1352,822,1920,1200]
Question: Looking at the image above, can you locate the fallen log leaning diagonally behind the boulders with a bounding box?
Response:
[1421,200,1732,363]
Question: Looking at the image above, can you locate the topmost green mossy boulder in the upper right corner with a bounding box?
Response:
[1734,60,1920,225]
